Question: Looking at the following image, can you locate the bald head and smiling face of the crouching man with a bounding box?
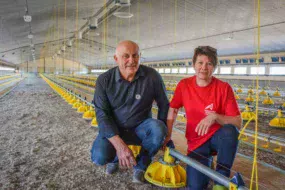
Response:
[114,43,140,77]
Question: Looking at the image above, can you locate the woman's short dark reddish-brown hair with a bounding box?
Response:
[192,46,218,67]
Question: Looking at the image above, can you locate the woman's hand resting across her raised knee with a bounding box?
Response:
[195,113,217,136]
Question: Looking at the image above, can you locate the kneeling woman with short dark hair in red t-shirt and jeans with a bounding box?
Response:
[165,46,242,190]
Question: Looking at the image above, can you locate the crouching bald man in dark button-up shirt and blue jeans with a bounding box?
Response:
[91,41,169,183]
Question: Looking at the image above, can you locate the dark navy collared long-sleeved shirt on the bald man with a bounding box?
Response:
[94,65,169,138]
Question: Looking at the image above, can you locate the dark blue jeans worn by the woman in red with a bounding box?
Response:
[186,125,239,190]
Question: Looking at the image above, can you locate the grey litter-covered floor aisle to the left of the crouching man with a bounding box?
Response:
[0,74,158,189]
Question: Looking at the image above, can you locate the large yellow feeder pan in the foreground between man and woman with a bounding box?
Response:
[144,148,186,188]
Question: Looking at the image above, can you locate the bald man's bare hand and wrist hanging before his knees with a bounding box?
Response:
[108,135,137,168]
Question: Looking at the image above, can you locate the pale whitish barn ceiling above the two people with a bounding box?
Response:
[0,0,285,67]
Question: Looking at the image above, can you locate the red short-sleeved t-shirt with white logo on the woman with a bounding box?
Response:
[170,76,240,153]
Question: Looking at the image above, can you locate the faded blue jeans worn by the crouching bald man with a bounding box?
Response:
[91,118,167,171]
